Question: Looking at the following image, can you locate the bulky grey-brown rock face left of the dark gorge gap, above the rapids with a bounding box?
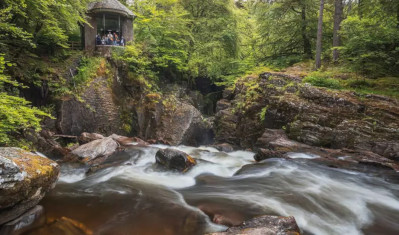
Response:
[134,95,213,146]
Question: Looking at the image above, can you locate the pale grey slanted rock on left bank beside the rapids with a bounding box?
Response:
[65,137,119,164]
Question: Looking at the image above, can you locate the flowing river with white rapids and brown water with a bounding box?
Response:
[20,145,399,235]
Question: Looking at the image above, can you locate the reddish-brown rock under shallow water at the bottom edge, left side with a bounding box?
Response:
[24,217,93,235]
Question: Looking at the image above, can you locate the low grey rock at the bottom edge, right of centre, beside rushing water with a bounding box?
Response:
[212,215,301,235]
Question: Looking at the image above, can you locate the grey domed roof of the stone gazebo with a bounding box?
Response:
[88,0,135,17]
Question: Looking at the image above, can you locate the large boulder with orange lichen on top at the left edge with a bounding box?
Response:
[0,148,59,224]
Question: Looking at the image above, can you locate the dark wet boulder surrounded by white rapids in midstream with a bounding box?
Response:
[155,149,197,172]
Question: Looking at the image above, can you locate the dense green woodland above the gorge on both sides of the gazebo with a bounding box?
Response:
[0,0,399,145]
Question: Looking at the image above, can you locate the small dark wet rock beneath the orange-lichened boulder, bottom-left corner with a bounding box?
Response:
[0,205,46,234]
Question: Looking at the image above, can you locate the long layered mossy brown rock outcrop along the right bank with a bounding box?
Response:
[215,73,399,160]
